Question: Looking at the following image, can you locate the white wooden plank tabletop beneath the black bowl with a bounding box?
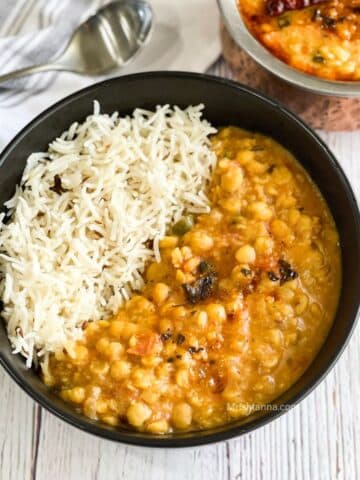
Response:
[0,62,360,480]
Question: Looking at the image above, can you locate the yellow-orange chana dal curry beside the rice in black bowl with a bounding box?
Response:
[44,127,341,434]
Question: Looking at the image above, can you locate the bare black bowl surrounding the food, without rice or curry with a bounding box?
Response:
[0,72,360,447]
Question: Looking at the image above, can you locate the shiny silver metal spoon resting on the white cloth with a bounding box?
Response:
[0,0,153,82]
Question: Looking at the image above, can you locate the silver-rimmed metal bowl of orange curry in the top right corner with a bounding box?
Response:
[219,0,360,97]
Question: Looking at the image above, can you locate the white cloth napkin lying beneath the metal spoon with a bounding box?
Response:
[0,0,220,150]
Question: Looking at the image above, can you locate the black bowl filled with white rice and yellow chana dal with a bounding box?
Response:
[0,72,360,447]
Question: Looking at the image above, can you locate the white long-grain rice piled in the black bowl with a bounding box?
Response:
[0,102,215,367]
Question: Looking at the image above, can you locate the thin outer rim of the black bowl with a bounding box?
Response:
[0,71,360,448]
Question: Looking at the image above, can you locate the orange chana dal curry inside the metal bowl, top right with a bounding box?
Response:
[239,0,360,81]
